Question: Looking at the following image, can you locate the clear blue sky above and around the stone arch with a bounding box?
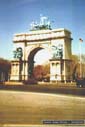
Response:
[0,0,85,59]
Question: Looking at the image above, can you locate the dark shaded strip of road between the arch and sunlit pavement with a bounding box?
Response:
[0,83,85,96]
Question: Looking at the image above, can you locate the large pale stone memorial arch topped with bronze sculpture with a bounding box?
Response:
[10,17,72,81]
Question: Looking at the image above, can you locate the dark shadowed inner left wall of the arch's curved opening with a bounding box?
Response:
[28,47,43,78]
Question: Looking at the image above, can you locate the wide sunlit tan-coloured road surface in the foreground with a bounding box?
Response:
[0,90,85,125]
